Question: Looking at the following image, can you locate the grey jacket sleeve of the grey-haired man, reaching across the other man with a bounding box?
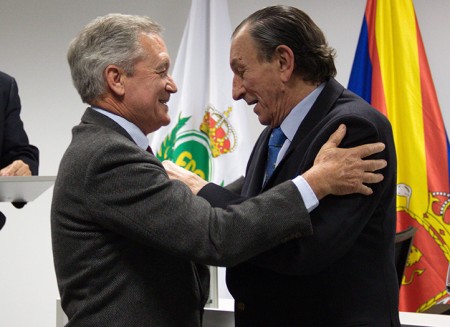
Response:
[78,141,311,266]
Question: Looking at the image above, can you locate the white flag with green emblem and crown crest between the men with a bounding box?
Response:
[152,0,251,185]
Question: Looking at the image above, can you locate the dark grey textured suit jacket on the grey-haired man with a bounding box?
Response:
[51,109,311,327]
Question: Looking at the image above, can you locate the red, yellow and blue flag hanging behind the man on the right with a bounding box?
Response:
[348,0,450,312]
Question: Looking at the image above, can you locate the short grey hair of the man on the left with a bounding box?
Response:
[67,14,162,103]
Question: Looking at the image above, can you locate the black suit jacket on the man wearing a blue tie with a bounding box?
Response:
[199,79,400,327]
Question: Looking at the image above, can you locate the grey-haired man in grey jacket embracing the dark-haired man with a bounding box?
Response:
[51,14,386,327]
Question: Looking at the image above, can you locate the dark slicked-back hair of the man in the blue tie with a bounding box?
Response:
[233,6,336,82]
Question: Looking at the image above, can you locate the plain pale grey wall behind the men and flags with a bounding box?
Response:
[0,0,450,327]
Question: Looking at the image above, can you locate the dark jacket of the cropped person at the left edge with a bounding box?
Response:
[0,72,39,175]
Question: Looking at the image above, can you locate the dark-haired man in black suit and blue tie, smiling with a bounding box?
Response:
[166,6,400,327]
